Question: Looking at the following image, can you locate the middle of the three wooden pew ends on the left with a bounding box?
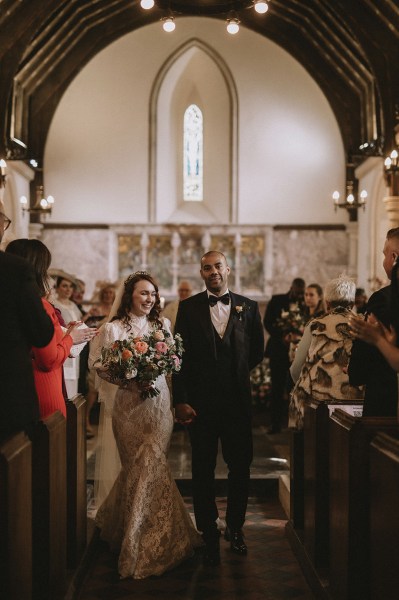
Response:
[32,411,67,600]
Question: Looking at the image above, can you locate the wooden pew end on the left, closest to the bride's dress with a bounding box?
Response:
[67,394,87,569]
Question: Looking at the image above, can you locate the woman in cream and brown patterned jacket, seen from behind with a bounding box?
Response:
[288,275,363,429]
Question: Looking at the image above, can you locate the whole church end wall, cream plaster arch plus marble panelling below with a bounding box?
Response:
[10,18,378,299]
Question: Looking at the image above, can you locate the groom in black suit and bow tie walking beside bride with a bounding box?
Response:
[173,251,264,565]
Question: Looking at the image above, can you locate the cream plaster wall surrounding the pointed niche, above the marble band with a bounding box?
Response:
[44,18,347,224]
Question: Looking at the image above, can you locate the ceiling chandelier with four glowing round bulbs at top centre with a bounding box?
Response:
[140,0,270,35]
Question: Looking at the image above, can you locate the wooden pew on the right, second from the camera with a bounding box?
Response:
[329,409,399,600]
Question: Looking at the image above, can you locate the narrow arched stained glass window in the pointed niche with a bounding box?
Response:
[183,104,203,201]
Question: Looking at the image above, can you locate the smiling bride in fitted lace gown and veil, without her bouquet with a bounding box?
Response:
[89,271,202,579]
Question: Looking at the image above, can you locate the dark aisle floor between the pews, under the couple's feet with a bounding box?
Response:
[79,497,314,600]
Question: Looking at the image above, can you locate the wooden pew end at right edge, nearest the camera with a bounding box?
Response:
[370,433,399,600]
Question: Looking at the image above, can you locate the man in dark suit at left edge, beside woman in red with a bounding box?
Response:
[0,200,54,442]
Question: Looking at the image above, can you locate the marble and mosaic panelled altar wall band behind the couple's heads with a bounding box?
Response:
[42,225,349,302]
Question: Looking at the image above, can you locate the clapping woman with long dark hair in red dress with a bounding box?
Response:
[6,239,97,419]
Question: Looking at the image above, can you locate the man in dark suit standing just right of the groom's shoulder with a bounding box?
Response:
[263,277,305,434]
